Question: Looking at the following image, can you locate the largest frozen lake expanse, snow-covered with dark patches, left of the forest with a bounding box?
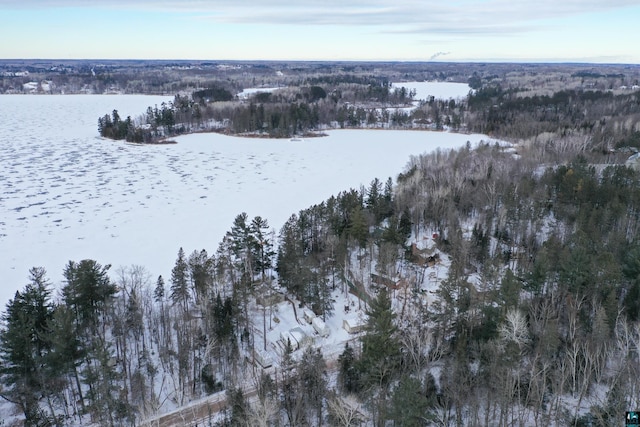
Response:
[0,95,496,310]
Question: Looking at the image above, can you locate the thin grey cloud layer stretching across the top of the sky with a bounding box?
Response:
[0,0,638,36]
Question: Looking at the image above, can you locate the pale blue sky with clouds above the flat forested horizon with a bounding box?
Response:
[0,0,640,64]
